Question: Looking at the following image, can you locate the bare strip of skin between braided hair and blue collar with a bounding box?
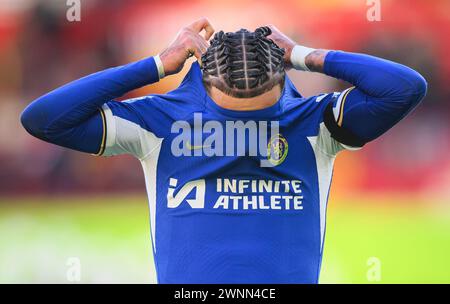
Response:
[209,85,281,111]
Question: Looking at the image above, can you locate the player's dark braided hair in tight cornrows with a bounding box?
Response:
[202,26,285,98]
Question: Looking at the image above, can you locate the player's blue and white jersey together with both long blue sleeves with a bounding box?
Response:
[21,52,426,283]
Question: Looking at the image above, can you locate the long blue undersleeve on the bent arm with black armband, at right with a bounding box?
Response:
[324,51,427,142]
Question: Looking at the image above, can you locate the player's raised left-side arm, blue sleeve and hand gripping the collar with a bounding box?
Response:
[21,18,214,154]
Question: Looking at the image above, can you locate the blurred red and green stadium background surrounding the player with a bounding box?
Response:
[0,0,450,283]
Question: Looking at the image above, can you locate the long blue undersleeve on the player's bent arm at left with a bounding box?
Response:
[21,57,159,154]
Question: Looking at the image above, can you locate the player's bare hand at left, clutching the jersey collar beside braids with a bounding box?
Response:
[159,17,214,75]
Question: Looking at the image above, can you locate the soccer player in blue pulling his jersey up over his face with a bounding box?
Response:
[21,18,427,283]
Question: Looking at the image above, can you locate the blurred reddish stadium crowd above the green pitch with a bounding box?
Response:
[0,0,450,200]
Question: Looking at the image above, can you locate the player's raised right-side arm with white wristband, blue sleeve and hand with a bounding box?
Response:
[270,26,427,146]
